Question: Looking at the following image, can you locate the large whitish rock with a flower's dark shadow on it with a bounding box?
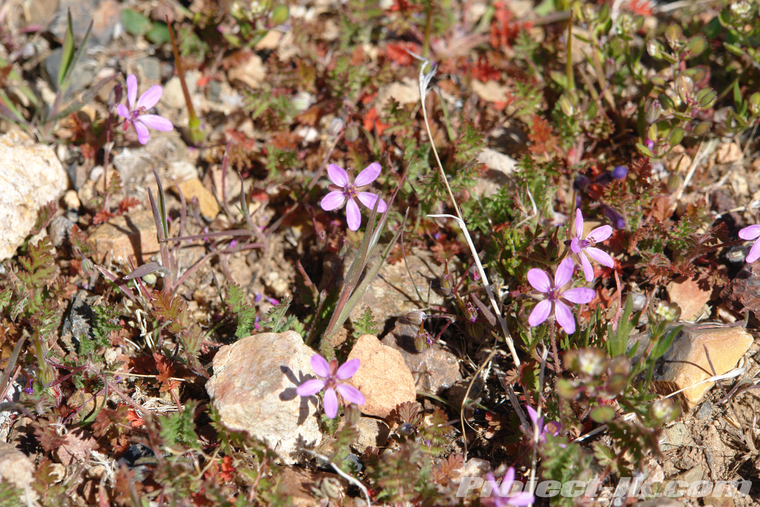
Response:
[206,331,322,464]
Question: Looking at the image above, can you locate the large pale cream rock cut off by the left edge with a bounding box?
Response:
[0,132,69,261]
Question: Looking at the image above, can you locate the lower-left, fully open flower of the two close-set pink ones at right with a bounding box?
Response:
[528,257,596,334]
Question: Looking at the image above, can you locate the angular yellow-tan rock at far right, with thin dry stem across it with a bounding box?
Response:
[653,324,754,410]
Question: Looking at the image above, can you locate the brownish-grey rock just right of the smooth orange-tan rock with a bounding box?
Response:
[382,319,462,395]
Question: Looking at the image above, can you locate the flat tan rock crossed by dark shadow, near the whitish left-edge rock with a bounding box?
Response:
[87,210,159,264]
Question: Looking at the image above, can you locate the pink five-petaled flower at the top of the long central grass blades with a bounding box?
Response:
[319,162,388,231]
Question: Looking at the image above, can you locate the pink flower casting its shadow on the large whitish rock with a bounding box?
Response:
[296,354,367,419]
